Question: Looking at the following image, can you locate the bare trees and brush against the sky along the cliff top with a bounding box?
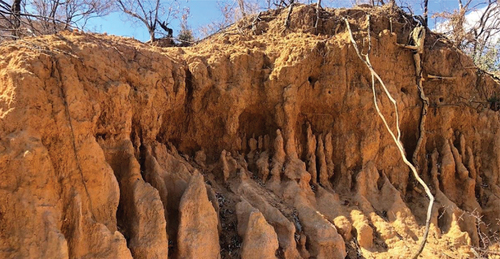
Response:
[0,0,500,73]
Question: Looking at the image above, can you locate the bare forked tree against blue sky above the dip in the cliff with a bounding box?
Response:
[116,0,179,42]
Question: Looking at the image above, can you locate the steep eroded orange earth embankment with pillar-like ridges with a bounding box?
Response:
[0,6,500,258]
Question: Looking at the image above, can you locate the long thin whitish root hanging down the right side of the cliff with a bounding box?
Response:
[344,15,434,258]
